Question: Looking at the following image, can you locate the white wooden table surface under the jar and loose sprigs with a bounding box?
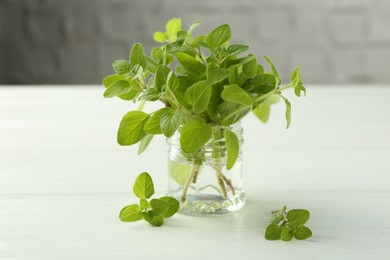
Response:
[0,85,390,260]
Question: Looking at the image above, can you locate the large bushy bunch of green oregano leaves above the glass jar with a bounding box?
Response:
[103,18,306,169]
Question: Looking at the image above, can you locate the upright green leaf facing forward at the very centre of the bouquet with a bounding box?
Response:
[185,81,211,114]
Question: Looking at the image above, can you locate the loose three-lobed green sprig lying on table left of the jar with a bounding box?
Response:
[119,172,179,226]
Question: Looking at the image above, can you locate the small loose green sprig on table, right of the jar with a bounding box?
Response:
[265,206,312,241]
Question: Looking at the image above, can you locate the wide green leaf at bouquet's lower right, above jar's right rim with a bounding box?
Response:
[218,101,252,125]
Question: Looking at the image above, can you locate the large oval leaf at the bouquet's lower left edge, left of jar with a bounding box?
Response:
[117,111,149,145]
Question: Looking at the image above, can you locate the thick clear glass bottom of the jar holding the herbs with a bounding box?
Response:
[179,192,245,216]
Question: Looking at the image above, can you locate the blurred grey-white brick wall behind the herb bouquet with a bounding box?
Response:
[0,0,390,84]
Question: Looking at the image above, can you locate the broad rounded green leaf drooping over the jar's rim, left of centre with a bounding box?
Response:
[180,122,212,153]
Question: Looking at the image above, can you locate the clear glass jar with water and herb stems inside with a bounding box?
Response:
[167,123,245,215]
